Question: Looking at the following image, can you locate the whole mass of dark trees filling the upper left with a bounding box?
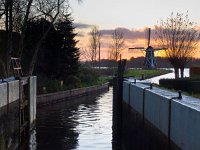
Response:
[0,0,80,78]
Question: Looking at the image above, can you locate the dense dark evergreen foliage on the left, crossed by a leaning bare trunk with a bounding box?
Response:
[23,14,79,80]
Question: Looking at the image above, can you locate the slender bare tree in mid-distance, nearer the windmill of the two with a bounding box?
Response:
[109,30,125,61]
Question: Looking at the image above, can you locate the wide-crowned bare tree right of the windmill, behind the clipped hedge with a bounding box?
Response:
[155,13,200,78]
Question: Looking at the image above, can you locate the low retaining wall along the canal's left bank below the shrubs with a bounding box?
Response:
[37,83,108,106]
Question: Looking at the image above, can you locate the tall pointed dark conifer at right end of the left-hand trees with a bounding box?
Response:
[56,14,80,78]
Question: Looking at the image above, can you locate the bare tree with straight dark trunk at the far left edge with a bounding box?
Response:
[0,0,33,76]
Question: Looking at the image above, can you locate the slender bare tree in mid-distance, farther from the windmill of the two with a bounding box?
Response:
[88,26,101,64]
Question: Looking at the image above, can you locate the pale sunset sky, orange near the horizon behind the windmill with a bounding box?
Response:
[70,0,200,58]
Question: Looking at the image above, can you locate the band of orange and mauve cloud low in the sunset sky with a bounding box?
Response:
[76,25,200,60]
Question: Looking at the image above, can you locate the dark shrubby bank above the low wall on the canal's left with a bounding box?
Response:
[37,67,108,94]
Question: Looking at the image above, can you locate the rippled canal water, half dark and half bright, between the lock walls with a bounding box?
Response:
[30,88,115,150]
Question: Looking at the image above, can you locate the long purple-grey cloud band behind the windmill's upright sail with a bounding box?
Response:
[101,28,154,39]
